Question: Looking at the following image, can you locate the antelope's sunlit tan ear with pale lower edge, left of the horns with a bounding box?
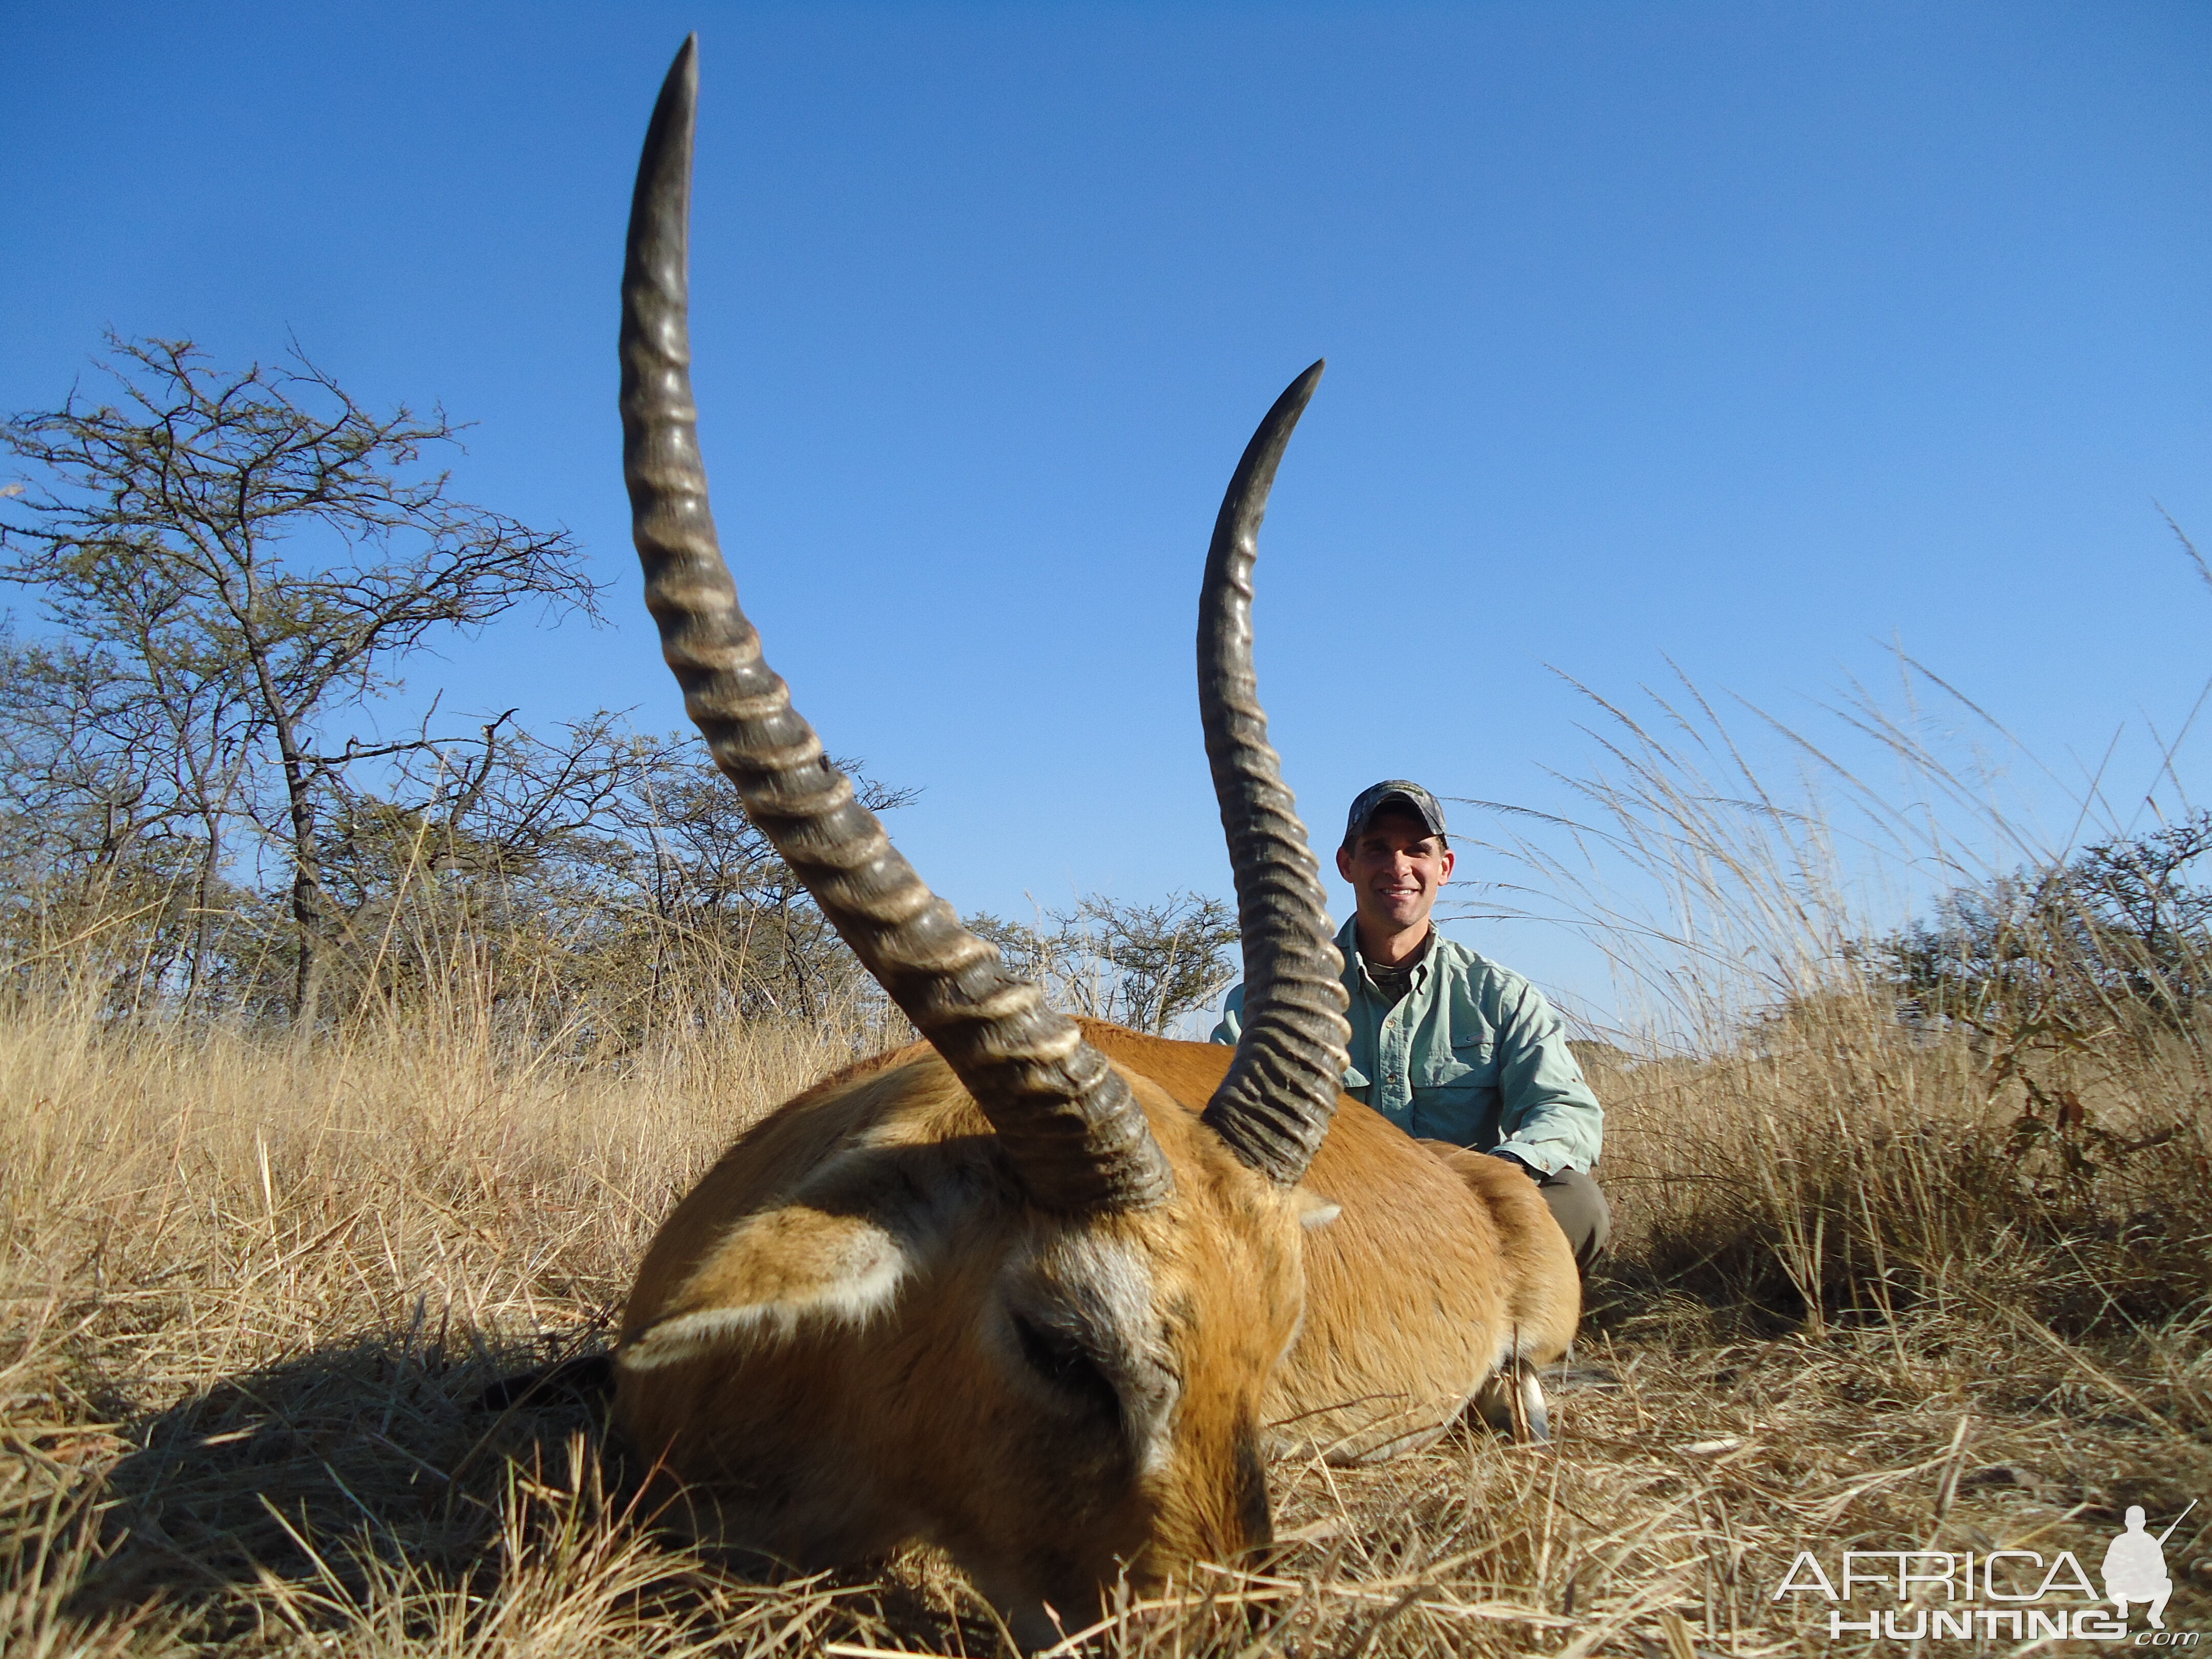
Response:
[617,1203,909,1371]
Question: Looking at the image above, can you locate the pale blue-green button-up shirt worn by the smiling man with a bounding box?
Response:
[1215,922,1606,1175]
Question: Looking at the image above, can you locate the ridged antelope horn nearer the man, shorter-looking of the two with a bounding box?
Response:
[1199,363,1352,1183]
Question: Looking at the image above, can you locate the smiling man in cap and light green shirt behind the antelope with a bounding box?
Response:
[1215,779,1612,1267]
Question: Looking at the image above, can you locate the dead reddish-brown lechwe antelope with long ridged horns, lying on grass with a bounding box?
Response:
[615,42,1579,1641]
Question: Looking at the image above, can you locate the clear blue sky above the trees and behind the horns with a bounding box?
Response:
[0,0,2212,1026]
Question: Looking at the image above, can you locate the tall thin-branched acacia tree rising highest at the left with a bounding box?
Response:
[0,336,597,1020]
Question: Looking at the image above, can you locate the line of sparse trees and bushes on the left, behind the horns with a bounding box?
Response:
[0,336,1237,1044]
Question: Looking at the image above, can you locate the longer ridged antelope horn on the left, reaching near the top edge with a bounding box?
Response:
[622,35,1175,1210]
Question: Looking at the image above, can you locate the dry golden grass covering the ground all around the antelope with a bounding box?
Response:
[0,969,2212,1657]
